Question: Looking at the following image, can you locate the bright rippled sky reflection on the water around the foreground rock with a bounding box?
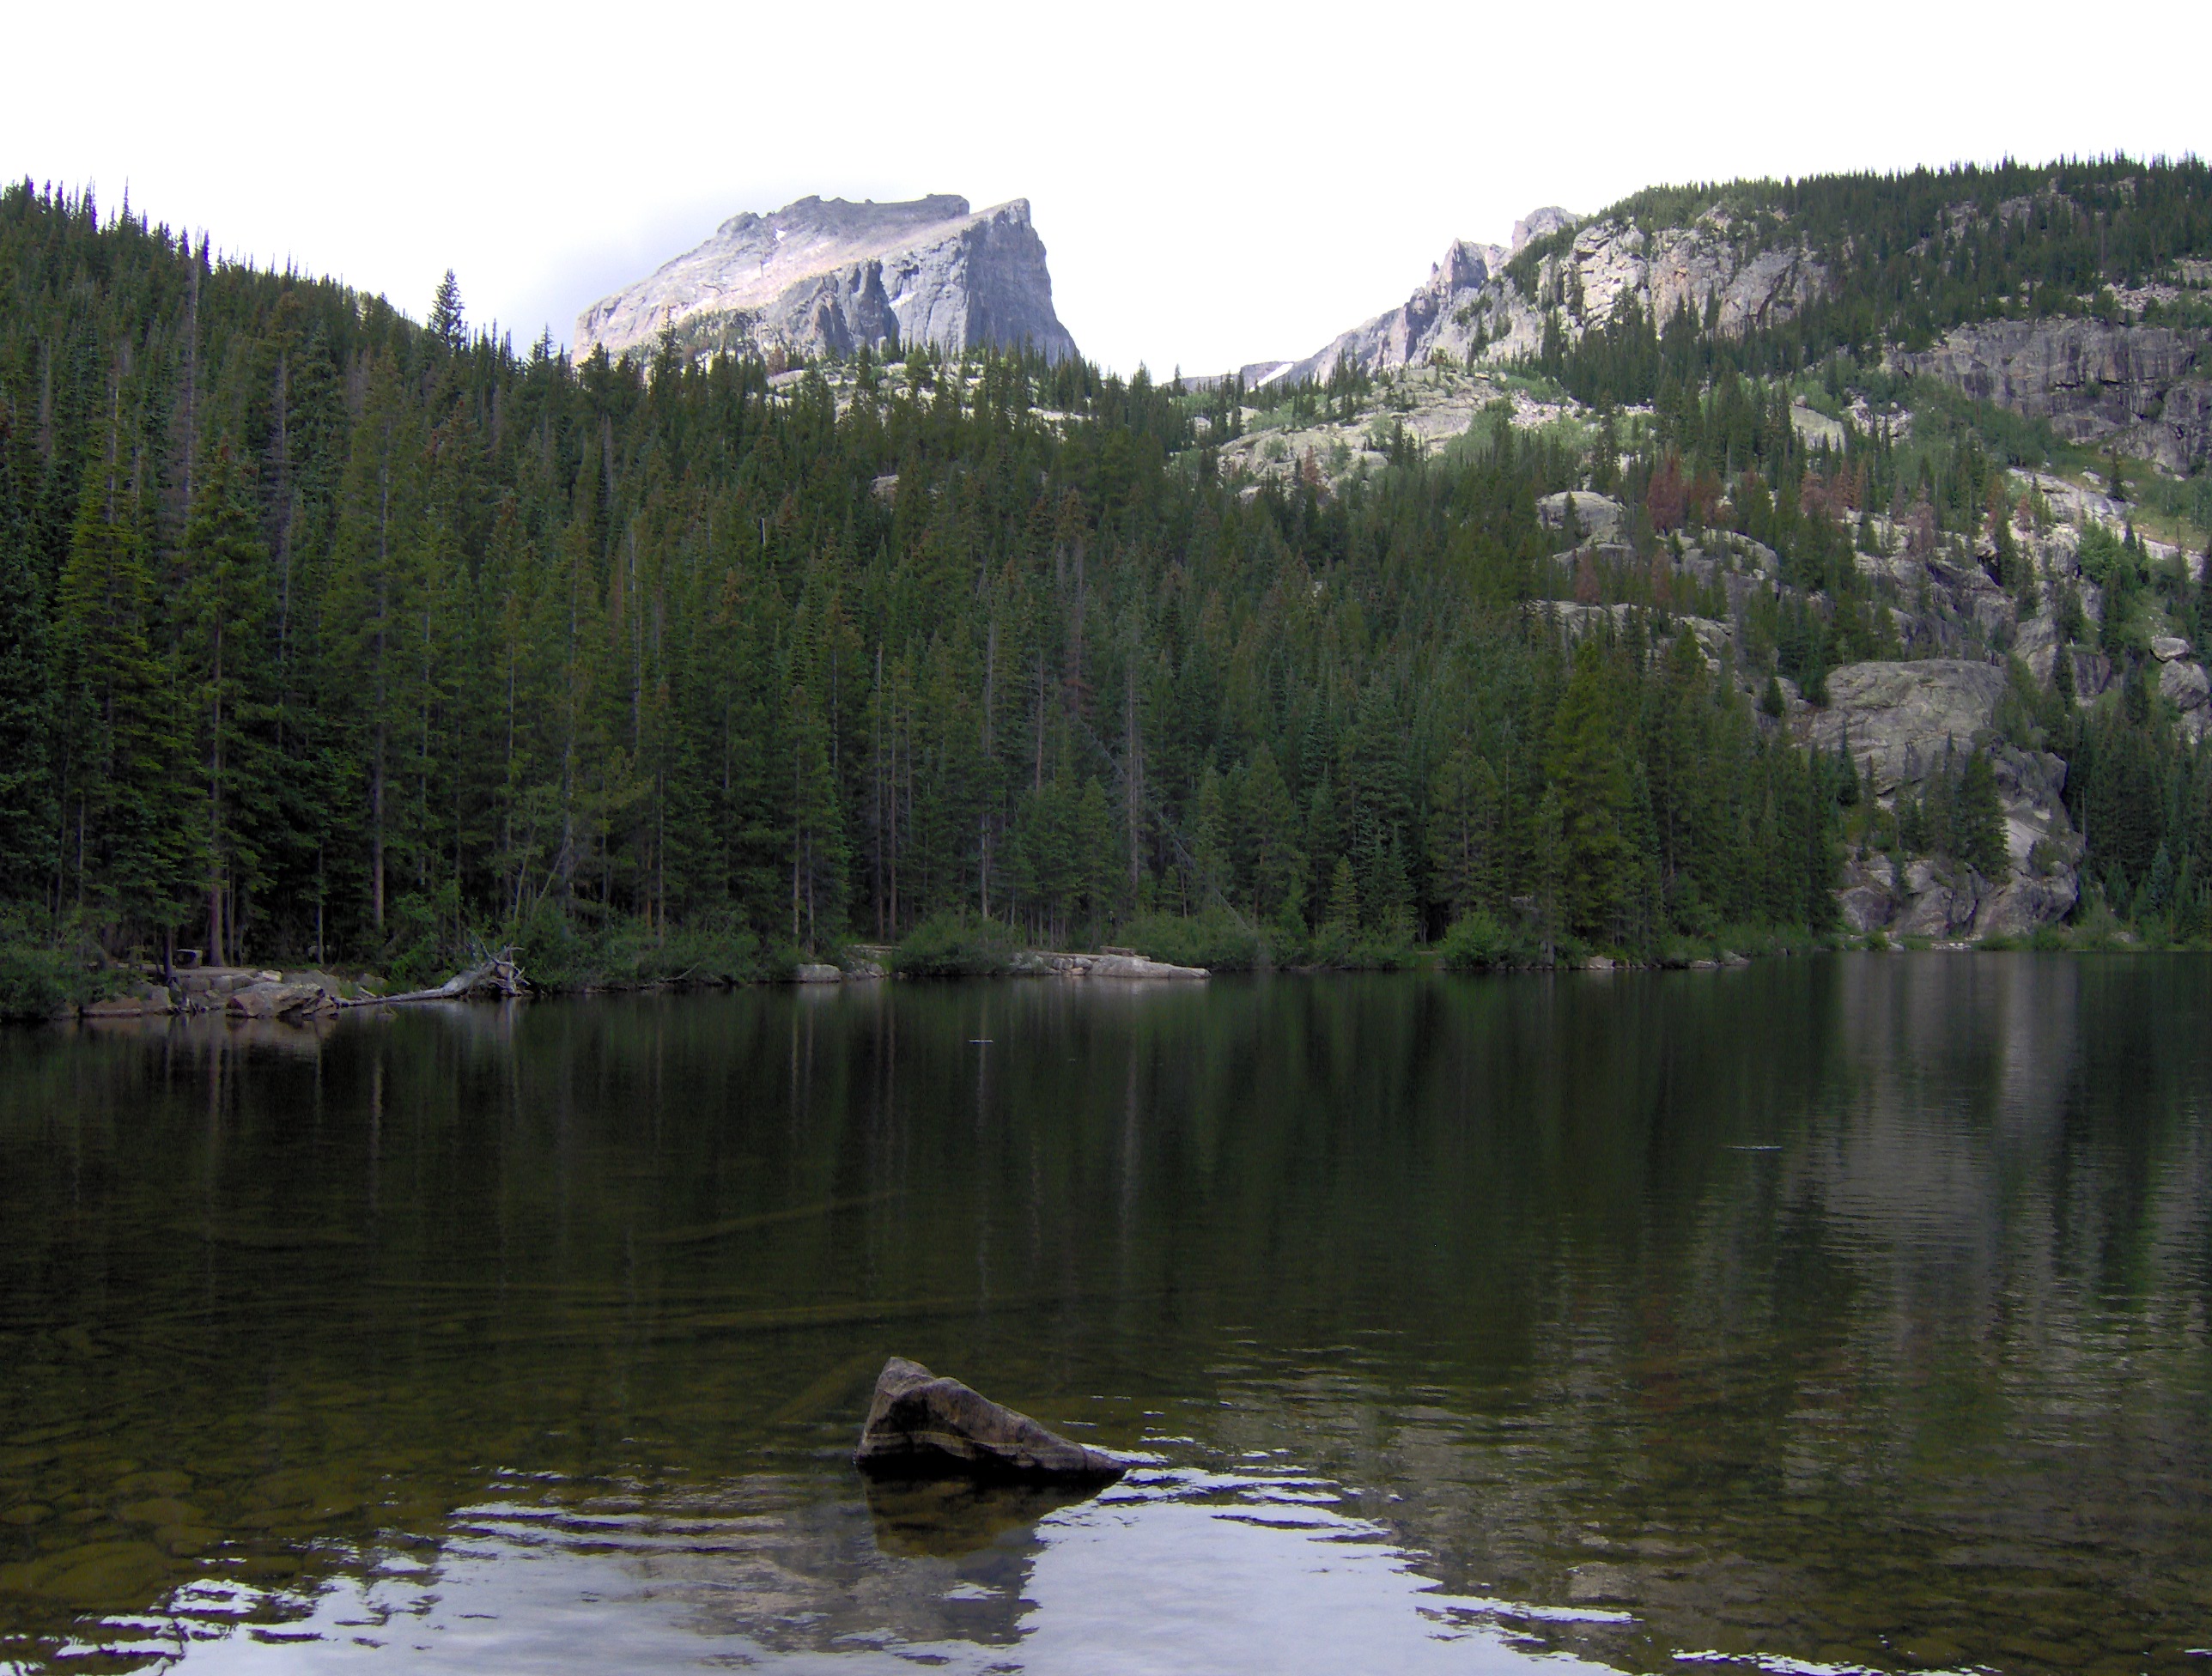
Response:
[77,1466,1628,1676]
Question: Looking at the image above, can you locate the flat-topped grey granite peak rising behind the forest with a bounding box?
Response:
[575,197,1075,361]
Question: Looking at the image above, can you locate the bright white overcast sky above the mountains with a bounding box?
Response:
[0,0,2212,372]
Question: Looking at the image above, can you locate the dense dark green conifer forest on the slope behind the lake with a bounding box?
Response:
[0,184,1854,999]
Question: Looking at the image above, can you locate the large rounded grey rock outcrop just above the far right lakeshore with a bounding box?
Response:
[1798,659,2081,939]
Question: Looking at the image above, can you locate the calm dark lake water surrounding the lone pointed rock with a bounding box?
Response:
[0,955,2212,1676]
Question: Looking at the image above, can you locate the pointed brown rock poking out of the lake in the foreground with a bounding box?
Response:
[852,1356,1128,1484]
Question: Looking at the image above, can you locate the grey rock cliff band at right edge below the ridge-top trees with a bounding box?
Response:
[1896,319,2212,473]
